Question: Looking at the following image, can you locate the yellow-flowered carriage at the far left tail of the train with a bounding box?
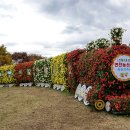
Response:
[0,65,15,87]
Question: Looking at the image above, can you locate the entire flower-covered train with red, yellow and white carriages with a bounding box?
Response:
[0,28,130,114]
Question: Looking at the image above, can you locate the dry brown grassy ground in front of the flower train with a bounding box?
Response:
[0,87,130,130]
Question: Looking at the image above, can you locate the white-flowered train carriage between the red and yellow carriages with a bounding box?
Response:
[33,58,51,87]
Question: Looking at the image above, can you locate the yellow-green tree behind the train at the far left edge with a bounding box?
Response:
[0,44,12,66]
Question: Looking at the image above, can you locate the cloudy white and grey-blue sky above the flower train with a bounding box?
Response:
[0,0,130,57]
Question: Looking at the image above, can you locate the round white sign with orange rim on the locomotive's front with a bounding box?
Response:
[111,54,130,81]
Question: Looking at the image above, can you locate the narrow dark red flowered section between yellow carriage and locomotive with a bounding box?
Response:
[67,49,86,93]
